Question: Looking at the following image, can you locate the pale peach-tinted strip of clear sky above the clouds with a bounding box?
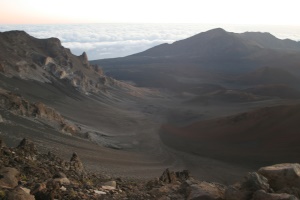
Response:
[0,0,300,26]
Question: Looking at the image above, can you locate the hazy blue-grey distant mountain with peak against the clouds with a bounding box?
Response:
[91,28,300,90]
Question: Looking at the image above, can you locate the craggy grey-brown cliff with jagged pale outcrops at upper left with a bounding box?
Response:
[0,31,107,92]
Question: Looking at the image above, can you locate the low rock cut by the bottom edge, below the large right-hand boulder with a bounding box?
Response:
[252,190,298,200]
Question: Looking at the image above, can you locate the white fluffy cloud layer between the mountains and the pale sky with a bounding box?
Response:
[0,24,300,60]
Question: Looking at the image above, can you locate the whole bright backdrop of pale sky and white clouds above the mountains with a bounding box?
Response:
[0,0,300,60]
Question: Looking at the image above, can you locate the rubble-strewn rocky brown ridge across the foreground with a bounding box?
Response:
[0,139,300,200]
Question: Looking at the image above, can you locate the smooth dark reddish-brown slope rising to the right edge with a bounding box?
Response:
[161,105,300,166]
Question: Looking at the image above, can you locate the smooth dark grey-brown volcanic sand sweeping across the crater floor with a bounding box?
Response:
[0,77,298,183]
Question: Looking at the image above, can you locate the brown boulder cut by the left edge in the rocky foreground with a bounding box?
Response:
[0,167,20,188]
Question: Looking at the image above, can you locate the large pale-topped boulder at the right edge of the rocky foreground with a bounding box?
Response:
[258,163,300,191]
